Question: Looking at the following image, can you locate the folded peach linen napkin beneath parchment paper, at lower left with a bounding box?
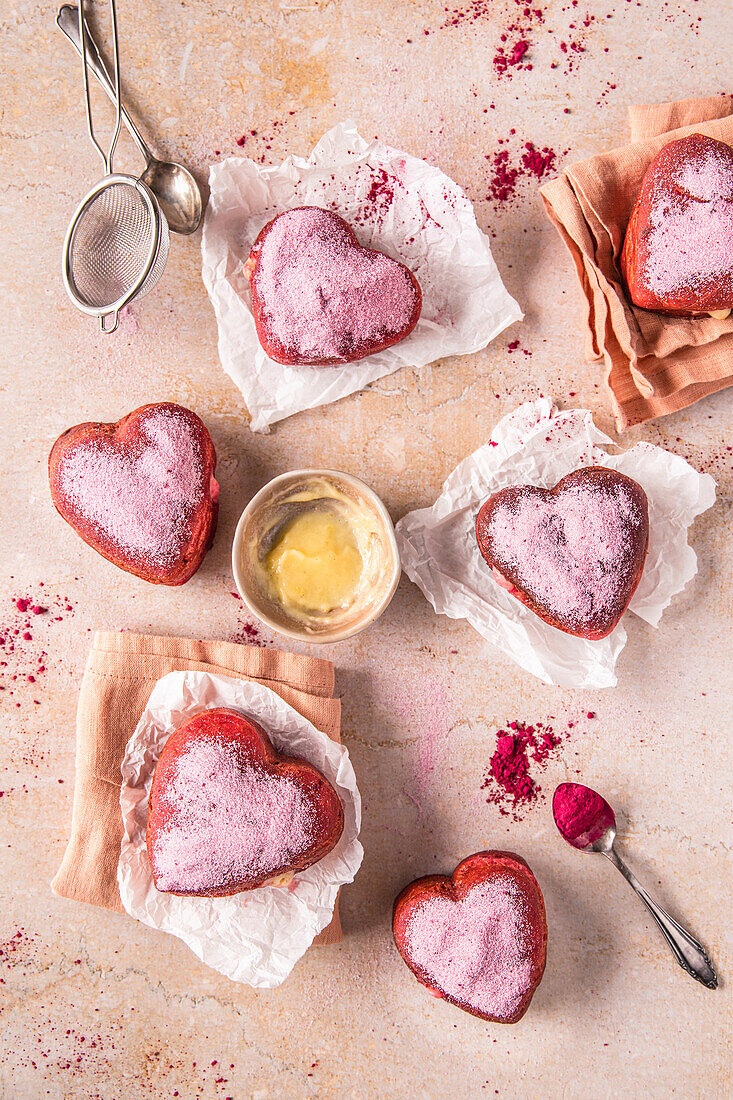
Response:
[51,630,342,944]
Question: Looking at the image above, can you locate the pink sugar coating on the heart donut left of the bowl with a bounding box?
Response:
[58,408,207,567]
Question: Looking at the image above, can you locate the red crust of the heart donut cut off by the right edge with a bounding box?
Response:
[621,134,733,317]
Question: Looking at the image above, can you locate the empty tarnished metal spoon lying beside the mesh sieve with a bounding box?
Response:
[56,4,204,233]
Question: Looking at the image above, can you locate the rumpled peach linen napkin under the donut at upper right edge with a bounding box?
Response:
[540,96,733,431]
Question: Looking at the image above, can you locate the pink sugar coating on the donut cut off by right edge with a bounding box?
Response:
[645,135,733,304]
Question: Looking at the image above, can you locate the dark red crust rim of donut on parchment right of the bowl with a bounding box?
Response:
[475,466,649,641]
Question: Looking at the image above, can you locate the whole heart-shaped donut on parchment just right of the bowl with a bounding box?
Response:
[475,466,649,639]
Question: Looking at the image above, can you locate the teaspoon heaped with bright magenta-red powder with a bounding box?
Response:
[553,783,718,989]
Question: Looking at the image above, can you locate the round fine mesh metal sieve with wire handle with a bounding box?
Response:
[64,0,169,332]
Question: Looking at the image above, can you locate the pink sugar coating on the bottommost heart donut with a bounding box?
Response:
[406,876,533,1020]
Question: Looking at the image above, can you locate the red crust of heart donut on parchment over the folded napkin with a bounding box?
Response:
[145,707,343,898]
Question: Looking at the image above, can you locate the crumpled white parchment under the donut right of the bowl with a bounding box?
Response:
[396,398,715,688]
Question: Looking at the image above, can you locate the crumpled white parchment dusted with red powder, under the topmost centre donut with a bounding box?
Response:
[201,122,523,431]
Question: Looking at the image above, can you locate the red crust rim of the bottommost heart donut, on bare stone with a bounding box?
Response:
[392,851,547,1024]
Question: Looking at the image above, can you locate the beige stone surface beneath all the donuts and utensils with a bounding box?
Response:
[0,0,733,1100]
